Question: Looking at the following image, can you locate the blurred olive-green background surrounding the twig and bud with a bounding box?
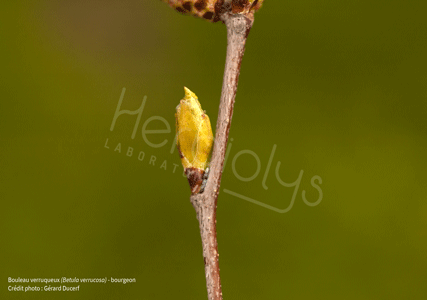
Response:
[0,0,427,299]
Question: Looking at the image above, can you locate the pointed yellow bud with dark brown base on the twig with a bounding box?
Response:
[175,87,213,194]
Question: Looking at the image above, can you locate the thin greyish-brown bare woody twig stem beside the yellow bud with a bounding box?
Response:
[190,12,254,300]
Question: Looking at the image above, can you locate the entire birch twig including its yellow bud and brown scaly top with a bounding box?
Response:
[162,0,264,300]
